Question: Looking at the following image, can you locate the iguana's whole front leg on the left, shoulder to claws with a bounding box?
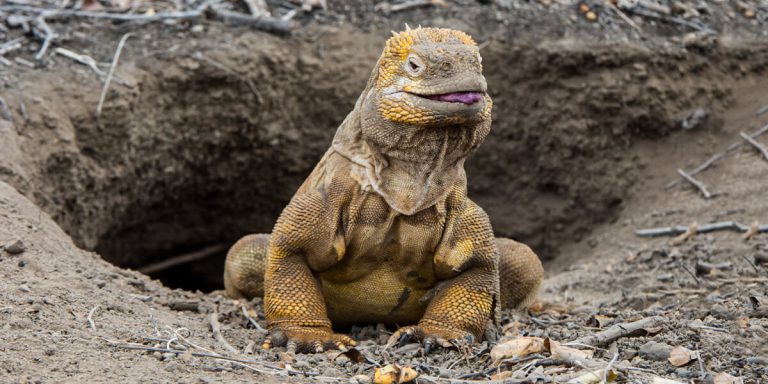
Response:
[263,189,355,352]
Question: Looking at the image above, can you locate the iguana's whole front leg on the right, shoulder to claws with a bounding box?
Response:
[388,200,499,352]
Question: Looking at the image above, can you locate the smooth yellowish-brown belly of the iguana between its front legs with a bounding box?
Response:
[319,262,428,326]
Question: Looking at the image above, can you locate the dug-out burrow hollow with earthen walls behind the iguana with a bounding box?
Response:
[0,27,768,291]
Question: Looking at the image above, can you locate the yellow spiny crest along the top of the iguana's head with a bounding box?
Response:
[384,24,475,61]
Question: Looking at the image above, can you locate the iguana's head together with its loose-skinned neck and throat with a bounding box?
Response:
[333,28,492,215]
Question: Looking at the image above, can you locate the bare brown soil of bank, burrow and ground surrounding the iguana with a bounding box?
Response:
[0,2,768,382]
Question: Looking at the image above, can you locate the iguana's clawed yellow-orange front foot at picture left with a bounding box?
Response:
[262,326,357,353]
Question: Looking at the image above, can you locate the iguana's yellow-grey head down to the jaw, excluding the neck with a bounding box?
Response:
[374,28,491,126]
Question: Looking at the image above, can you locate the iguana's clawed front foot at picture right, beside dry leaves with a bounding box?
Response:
[386,324,475,354]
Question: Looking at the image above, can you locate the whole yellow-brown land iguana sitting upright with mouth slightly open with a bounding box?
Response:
[224,28,543,353]
